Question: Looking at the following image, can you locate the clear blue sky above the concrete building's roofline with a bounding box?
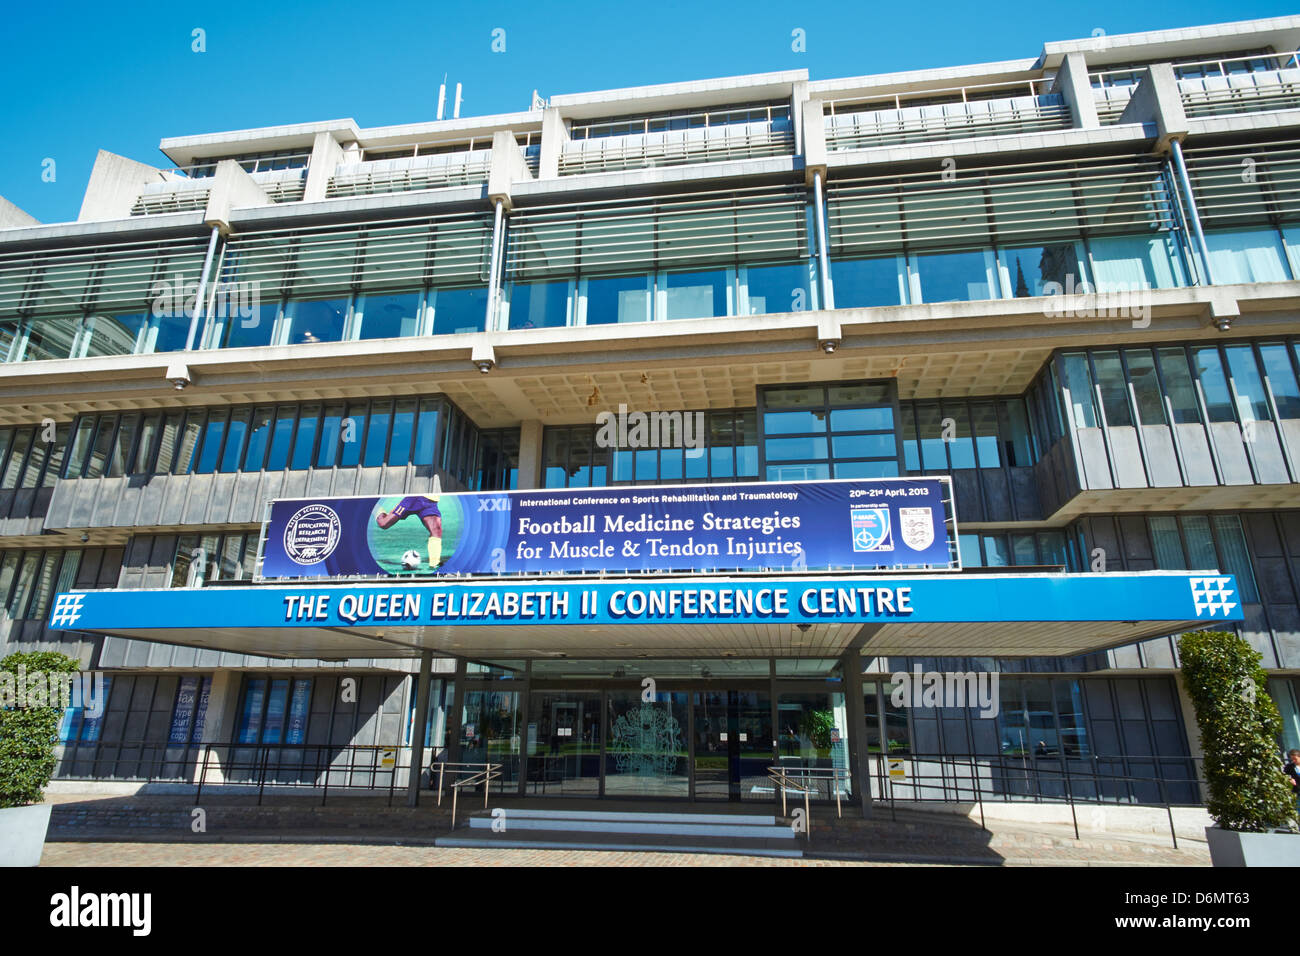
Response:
[0,0,1294,222]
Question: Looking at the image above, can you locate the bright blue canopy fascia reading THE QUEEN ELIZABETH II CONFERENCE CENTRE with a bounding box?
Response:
[51,571,1243,632]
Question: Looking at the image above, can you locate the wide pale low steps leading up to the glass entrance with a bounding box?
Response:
[436,809,803,857]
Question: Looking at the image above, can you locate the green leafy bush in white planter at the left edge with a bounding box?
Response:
[0,652,79,808]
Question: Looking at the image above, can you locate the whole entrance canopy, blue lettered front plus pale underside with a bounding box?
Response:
[49,572,1243,657]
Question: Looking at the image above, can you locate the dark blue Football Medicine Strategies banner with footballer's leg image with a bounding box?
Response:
[261,477,957,579]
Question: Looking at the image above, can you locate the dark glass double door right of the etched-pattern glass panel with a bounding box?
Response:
[693,689,774,800]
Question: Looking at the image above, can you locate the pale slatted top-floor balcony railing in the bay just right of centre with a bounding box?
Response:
[826,79,1073,150]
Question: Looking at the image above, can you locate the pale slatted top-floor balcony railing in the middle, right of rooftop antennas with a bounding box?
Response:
[560,113,794,176]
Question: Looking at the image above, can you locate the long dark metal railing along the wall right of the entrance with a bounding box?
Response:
[868,753,1203,848]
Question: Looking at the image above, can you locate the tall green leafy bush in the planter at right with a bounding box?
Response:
[1178,631,1296,832]
